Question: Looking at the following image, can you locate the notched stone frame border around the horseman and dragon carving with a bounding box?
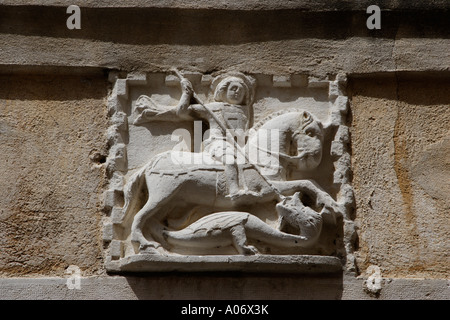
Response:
[102,72,356,272]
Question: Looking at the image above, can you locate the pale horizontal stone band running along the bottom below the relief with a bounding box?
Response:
[0,273,450,300]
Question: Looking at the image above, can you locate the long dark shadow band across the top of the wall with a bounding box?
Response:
[0,6,449,45]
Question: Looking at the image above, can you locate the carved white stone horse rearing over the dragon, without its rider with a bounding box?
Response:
[118,110,339,253]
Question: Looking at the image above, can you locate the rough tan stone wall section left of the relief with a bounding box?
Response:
[0,75,107,277]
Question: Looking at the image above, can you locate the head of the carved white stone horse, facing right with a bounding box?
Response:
[289,111,324,171]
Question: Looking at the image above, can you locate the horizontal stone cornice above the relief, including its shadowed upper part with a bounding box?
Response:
[0,5,450,77]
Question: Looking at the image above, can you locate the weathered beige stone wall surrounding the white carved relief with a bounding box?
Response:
[0,0,450,299]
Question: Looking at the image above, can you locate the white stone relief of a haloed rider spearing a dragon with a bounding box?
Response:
[104,70,354,271]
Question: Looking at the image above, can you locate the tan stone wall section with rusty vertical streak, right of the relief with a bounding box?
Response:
[351,77,450,278]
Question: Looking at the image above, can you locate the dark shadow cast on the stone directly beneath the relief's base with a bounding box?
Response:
[121,273,343,300]
